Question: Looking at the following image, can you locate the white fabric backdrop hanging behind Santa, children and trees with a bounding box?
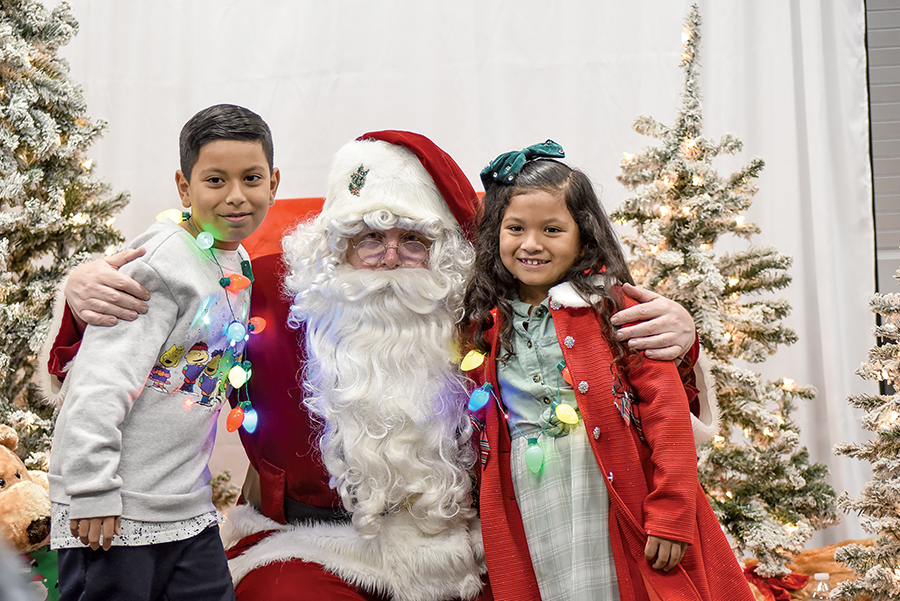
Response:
[46,0,876,544]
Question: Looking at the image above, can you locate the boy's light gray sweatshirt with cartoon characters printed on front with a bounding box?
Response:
[49,220,250,522]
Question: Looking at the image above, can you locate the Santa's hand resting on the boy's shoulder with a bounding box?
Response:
[63,248,150,330]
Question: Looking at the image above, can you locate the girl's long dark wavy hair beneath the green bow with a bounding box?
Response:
[458,159,634,362]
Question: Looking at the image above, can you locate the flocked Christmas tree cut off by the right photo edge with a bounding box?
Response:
[834,271,900,601]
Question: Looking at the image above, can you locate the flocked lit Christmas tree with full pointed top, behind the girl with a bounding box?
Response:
[612,5,837,577]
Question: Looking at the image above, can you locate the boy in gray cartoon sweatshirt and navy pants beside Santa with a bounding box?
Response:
[50,105,280,601]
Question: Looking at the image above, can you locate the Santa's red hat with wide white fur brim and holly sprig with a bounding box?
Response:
[321,130,478,240]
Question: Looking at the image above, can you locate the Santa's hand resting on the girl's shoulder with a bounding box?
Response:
[610,284,696,361]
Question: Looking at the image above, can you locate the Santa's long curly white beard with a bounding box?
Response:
[288,264,475,537]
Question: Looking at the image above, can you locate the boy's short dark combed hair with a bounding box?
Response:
[178,104,275,181]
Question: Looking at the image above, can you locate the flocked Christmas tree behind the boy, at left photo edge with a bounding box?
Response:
[0,0,128,469]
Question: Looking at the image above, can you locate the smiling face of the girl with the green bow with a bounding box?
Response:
[500,190,581,306]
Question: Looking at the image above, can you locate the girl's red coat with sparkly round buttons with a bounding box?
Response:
[480,284,753,601]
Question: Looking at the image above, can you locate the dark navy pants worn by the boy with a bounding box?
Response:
[59,526,234,601]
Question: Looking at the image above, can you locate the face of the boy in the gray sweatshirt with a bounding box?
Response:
[175,140,280,250]
